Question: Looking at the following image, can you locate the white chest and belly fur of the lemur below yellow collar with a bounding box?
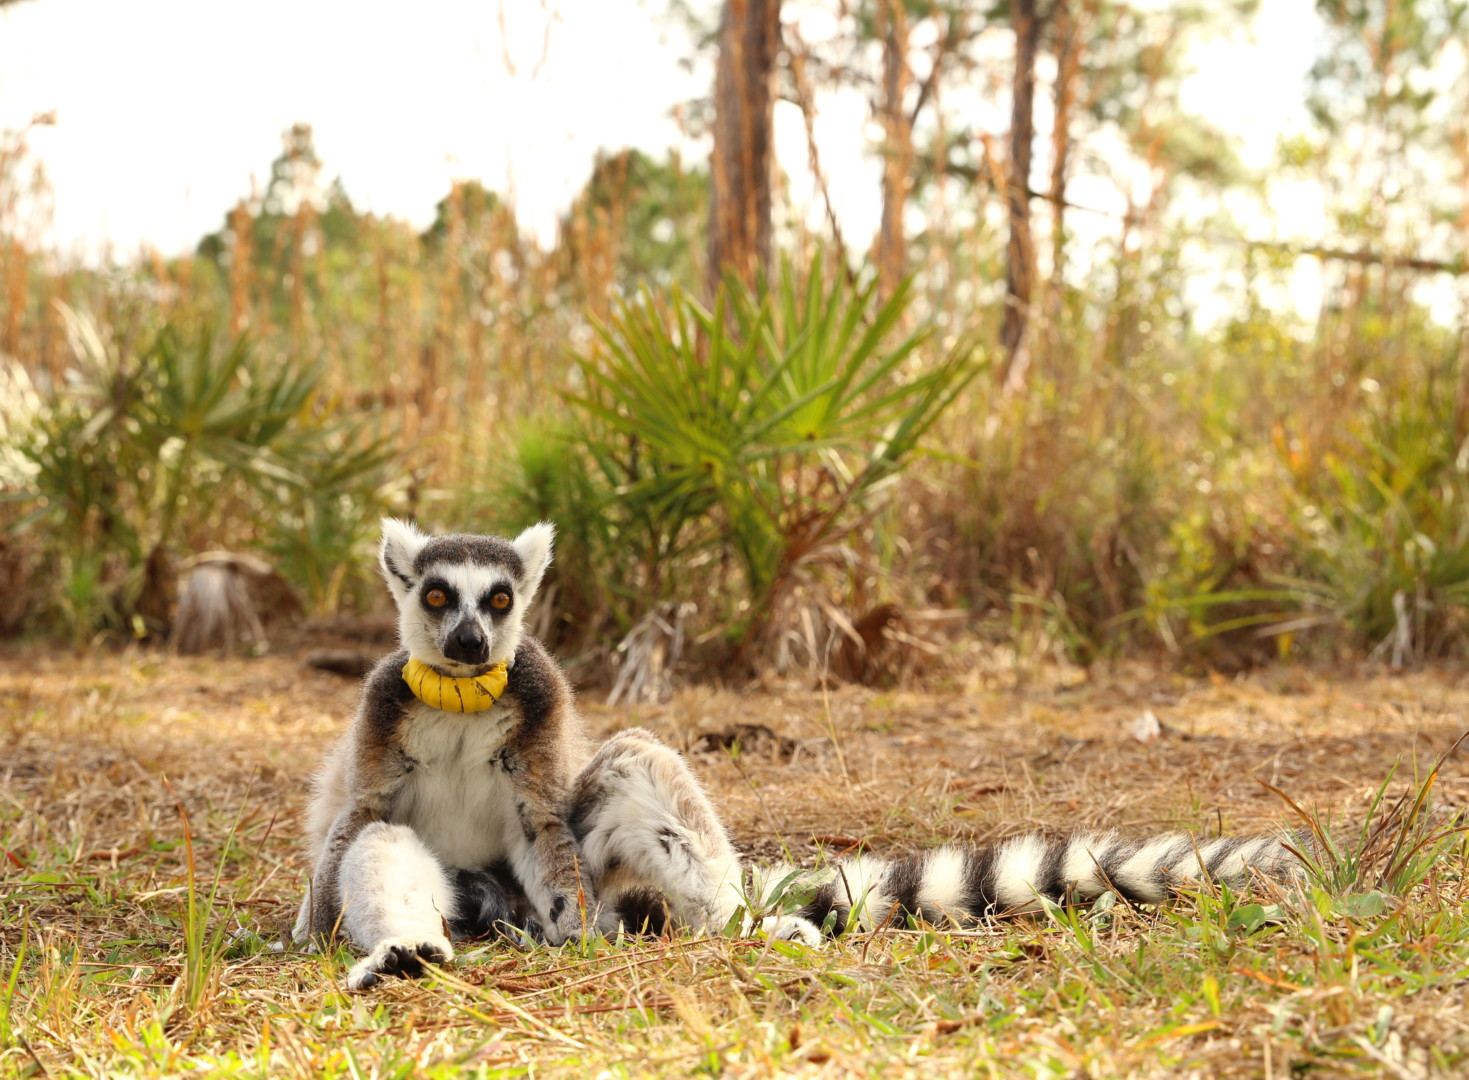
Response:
[392,702,520,868]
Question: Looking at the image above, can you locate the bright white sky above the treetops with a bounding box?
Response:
[0,0,1318,271]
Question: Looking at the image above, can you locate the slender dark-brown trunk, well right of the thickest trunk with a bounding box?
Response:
[1000,0,1044,391]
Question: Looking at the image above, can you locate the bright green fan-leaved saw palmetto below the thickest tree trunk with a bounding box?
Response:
[569,263,980,667]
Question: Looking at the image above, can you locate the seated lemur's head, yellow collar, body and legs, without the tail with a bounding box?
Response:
[294,520,740,989]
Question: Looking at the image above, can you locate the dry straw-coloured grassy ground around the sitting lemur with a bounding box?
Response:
[0,652,1469,1077]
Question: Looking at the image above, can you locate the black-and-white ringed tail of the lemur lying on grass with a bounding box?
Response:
[751,832,1304,943]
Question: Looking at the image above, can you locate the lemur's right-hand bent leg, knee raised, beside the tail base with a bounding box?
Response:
[569,729,742,933]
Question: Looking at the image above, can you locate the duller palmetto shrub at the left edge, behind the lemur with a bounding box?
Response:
[6,312,386,642]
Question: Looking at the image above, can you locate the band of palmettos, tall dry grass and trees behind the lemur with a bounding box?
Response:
[0,0,1469,669]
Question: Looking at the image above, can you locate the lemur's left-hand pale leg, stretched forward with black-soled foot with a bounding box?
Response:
[336,821,457,990]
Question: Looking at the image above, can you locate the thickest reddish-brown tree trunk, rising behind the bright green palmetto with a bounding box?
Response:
[710,0,780,295]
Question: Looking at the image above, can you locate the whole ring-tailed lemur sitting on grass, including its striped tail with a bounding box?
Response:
[294,519,1300,989]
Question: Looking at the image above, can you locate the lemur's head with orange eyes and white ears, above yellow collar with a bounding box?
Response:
[379,517,555,677]
